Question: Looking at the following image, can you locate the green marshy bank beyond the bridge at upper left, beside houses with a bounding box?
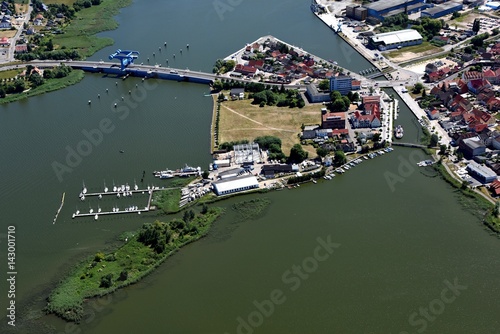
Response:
[53,0,132,57]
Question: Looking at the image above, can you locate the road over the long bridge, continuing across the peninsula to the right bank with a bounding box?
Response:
[0,60,415,89]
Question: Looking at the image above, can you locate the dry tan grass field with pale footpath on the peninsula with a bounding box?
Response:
[219,96,322,154]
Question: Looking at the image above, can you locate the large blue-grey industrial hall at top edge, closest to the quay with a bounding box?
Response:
[365,0,432,21]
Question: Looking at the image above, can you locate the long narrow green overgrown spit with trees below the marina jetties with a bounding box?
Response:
[45,207,223,322]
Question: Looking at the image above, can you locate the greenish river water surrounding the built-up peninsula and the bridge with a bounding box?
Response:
[0,0,500,334]
